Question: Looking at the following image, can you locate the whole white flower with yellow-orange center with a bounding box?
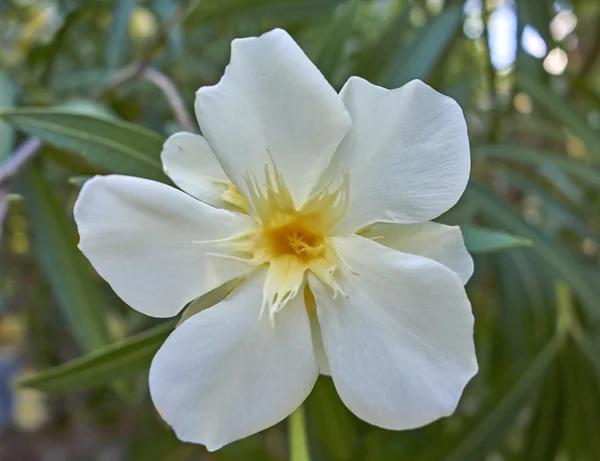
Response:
[75,30,477,450]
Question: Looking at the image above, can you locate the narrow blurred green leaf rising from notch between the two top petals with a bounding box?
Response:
[314,0,360,82]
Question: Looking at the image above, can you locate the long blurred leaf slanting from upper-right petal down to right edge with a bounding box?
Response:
[466,182,600,318]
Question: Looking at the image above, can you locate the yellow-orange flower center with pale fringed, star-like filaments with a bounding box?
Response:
[213,165,348,321]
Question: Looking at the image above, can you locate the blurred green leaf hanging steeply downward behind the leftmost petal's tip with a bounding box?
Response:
[21,164,108,352]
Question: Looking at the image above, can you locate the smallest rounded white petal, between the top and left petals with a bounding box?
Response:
[161,132,229,208]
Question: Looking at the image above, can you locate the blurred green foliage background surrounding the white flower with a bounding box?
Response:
[0,0,600,461]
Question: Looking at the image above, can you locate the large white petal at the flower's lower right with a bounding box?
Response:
[309,236,477,430]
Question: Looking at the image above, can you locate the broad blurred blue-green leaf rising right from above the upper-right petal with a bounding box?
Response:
[382,5,463,88]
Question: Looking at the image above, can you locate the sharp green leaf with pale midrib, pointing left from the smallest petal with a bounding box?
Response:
[0,109,166,181]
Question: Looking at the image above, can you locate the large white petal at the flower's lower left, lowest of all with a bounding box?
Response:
[150,271,318,451]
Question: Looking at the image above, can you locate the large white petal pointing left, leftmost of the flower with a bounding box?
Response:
[75,175,252,317]
